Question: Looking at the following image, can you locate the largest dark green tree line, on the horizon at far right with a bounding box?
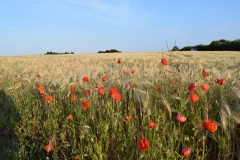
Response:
[180,39,240,51]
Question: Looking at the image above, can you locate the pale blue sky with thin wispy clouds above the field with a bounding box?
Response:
[0,0,240,56]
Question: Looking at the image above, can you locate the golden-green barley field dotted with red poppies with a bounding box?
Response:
[0,51,240,160]
